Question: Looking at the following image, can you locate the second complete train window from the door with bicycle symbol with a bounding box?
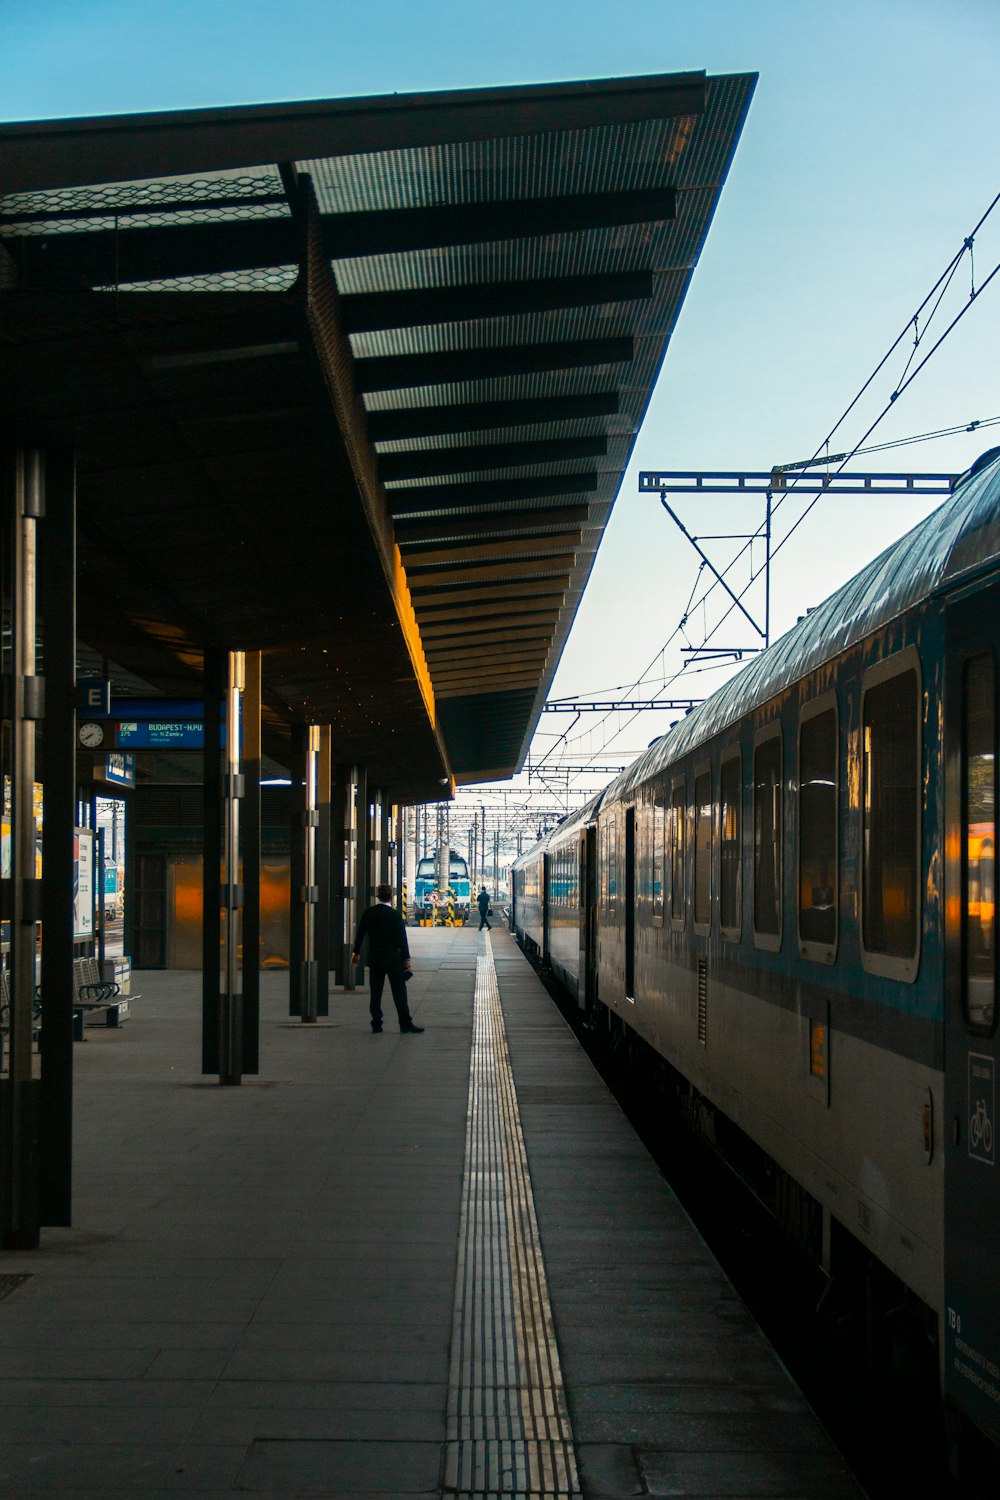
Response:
[799,699,838,963]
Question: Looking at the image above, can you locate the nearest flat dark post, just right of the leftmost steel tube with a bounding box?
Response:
[39,450,75,1226]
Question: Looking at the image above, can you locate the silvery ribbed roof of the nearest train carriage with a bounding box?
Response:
[588,449,1000,812]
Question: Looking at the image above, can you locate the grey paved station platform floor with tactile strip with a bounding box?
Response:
[0,927,862,1500]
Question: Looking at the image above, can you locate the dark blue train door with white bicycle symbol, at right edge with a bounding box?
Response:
[942,588,1000,1442]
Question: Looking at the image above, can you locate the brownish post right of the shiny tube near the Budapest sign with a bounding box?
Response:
[241,651,261,1073]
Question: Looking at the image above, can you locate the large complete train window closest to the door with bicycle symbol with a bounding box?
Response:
[861,651,921,980]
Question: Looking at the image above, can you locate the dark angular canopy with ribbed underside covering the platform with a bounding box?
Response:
[0,74,754,801]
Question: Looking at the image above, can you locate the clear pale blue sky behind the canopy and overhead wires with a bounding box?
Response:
[0,0,1000,846]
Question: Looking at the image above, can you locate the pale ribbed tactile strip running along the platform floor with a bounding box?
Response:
[442,932,582,1500]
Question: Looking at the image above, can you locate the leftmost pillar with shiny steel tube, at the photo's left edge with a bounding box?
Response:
[0,449,45,1250]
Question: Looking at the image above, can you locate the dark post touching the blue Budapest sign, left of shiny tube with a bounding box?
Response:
[201,648,228,1073]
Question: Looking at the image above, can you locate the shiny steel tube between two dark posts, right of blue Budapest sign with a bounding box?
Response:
[219,651,246,1083]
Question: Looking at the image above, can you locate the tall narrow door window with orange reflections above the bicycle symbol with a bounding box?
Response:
[963,656,997,1034]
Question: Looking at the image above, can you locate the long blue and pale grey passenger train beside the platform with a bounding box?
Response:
[511,449,1000,1473]
